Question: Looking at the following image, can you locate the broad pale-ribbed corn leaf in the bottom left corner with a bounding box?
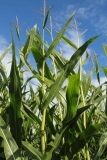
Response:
[0,116,21,160]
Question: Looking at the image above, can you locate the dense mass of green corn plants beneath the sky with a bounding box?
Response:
[0,1,107,160]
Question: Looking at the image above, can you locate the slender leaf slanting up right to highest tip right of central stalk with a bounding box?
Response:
[45,11,76,60]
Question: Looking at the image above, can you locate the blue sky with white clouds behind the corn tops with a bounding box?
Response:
[0,0,107,85]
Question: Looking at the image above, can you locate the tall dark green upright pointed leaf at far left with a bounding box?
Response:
[9,37,22,146]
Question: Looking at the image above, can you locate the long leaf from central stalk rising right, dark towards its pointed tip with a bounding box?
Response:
[42,36,99,108]
